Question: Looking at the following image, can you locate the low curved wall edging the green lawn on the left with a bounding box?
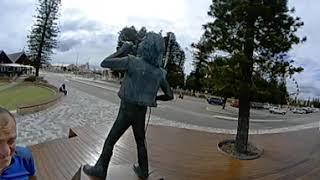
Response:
[17,83,62,115]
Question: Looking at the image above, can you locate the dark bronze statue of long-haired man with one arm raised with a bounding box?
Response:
[83,32,173,179]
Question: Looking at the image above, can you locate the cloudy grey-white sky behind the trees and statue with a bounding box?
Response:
[0,0,320,98]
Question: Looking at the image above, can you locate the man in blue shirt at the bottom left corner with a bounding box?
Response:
[0,107,37,180]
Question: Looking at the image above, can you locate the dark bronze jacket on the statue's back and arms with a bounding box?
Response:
[101,55,173,107]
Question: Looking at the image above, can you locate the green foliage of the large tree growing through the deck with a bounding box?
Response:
[192,0,306,102]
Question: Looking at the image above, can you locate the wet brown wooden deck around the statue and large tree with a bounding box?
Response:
[30,126,320,180]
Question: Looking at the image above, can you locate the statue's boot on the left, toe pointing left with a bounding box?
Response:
[83,147,112,179]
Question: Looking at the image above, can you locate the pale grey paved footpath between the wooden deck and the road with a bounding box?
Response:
[16,76,319,146]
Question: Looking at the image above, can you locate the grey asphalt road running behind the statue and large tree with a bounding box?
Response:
[45,73,320,129]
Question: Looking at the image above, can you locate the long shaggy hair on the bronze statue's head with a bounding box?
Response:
[137,32,165,67]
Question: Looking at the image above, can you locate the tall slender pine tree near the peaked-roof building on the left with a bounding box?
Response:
[28,0,61,76]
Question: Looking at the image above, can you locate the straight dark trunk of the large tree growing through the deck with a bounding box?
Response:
[235,13,255,153]
